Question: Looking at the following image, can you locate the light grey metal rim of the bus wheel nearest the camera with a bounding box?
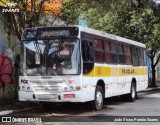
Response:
[96,90,103,109]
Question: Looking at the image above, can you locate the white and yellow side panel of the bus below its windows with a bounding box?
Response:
[82,64,148,101]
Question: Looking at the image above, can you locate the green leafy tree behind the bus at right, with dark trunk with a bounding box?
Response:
[85,0,160,86]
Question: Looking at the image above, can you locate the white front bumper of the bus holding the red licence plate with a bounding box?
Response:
[18,91,84,102]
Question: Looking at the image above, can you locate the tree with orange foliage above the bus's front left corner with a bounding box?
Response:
[1,0,62,41]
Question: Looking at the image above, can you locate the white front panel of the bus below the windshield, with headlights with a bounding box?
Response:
[19,75,85,102]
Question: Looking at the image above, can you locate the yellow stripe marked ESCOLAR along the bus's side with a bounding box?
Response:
[84,66,148,77]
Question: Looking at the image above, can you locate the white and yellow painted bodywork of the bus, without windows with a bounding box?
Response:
[19,26,148,102]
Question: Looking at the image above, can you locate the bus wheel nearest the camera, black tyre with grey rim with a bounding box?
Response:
[91,86,104,111]
